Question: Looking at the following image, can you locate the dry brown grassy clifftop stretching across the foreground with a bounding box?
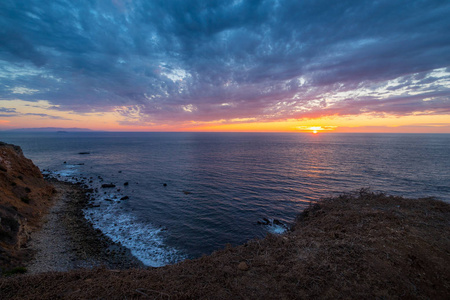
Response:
[0,190,450,299]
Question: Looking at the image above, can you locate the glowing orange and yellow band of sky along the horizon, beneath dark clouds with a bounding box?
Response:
[0,99,450,135]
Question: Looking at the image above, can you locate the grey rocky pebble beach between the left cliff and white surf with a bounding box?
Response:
[27,178,144,274]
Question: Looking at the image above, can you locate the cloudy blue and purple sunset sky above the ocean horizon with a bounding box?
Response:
[0,0,450,133]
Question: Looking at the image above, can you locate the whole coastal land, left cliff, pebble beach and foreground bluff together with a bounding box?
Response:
[0,144,450,299]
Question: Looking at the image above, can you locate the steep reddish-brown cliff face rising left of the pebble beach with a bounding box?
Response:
[0,142,54,269]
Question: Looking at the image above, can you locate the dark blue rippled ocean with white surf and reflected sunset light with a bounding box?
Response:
[0,132,450,266]
